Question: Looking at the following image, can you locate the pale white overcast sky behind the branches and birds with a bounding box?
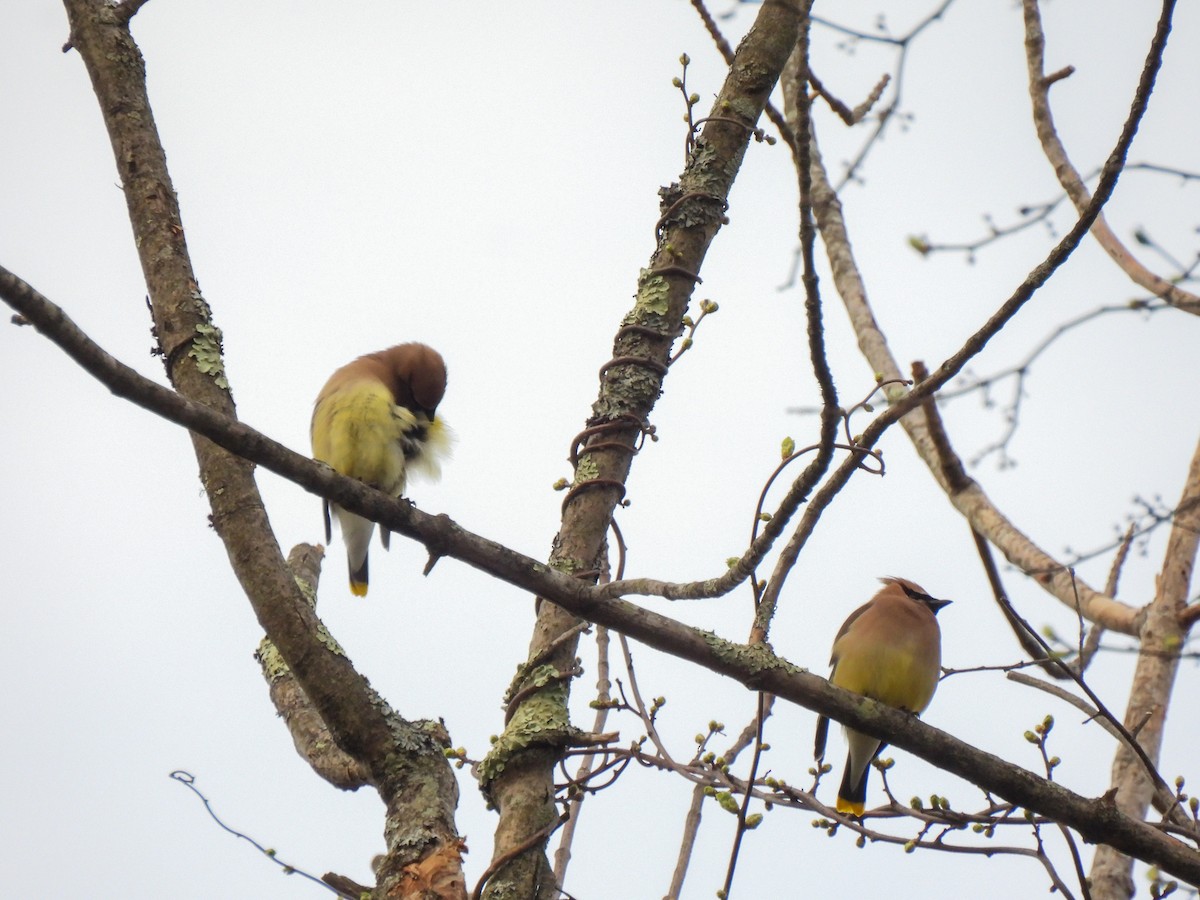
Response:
[0,0,1200,900]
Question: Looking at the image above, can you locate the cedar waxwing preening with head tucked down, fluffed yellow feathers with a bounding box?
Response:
[312,343,451,596]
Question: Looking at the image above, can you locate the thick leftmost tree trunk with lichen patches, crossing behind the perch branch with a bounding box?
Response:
[58,0,464,896]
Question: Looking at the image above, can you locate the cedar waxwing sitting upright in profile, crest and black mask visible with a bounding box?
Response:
[814,578,950,816]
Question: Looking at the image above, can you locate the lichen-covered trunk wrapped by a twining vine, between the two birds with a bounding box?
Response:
[480,0,800,900]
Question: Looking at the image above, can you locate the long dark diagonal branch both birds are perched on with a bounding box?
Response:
[0,269,1200,883]
